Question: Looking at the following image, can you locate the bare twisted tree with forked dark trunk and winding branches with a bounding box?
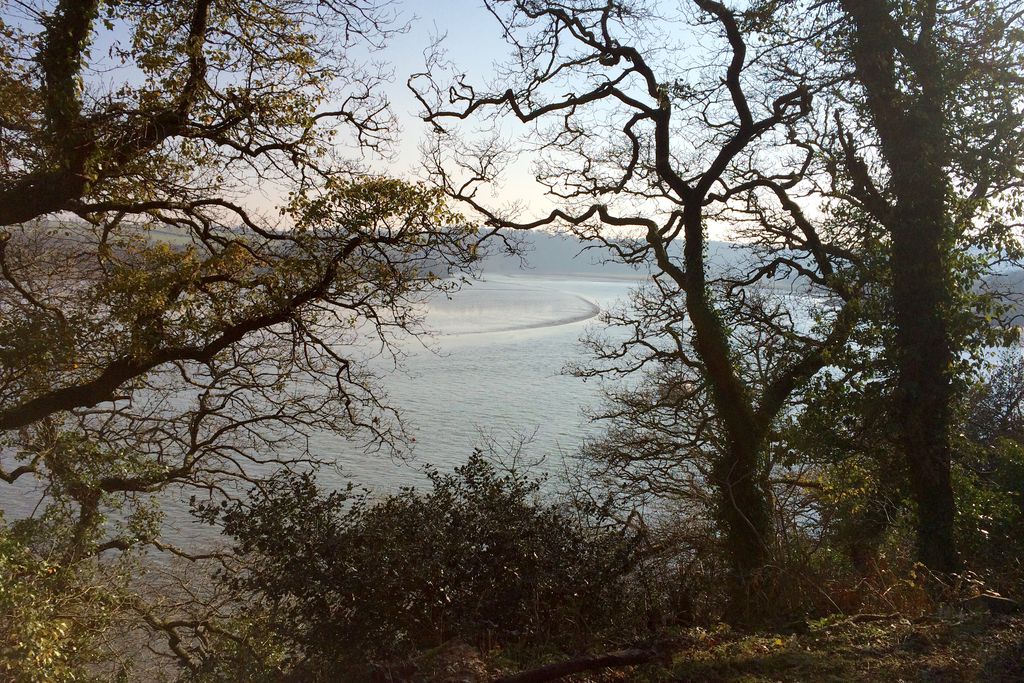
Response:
[410,0,861,621]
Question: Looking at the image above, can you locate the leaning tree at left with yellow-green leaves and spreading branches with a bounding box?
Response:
[0,0,474,663]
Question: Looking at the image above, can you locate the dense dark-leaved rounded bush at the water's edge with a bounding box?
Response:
[201,453,643,677]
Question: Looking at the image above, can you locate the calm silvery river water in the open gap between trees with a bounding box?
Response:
[0,275,638,545]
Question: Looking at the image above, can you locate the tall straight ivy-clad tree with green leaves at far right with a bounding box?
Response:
[774,0,1024,572]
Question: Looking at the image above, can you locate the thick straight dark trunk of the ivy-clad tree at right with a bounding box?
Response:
[841,0,958,572]
